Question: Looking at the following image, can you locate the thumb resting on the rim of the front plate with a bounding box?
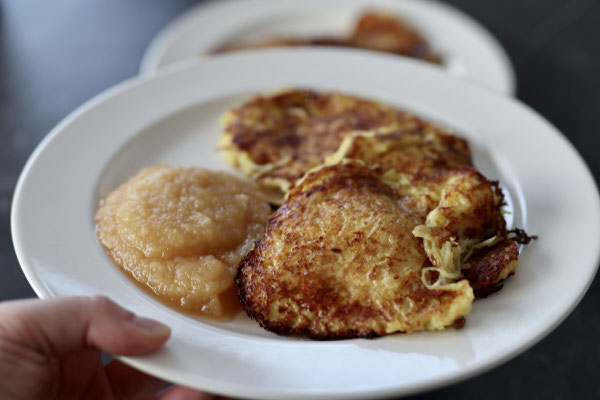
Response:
[0,296,170,356]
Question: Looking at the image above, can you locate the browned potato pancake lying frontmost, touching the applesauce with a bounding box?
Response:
[236,161,473,339]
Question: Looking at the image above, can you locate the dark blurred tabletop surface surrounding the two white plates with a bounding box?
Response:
[0,0,600,400]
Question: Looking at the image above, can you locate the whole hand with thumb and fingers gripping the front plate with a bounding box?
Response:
[0,296,227,400]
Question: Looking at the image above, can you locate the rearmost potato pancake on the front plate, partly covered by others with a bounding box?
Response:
[220,90,427,197]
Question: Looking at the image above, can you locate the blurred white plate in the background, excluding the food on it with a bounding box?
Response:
[140,0,515,95]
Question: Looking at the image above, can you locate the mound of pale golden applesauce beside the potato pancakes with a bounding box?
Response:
[96,165,271,318]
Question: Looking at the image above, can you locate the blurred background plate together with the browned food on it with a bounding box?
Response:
[140,0,516,95]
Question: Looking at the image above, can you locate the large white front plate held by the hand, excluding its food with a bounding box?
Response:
[12,49,600,399]
